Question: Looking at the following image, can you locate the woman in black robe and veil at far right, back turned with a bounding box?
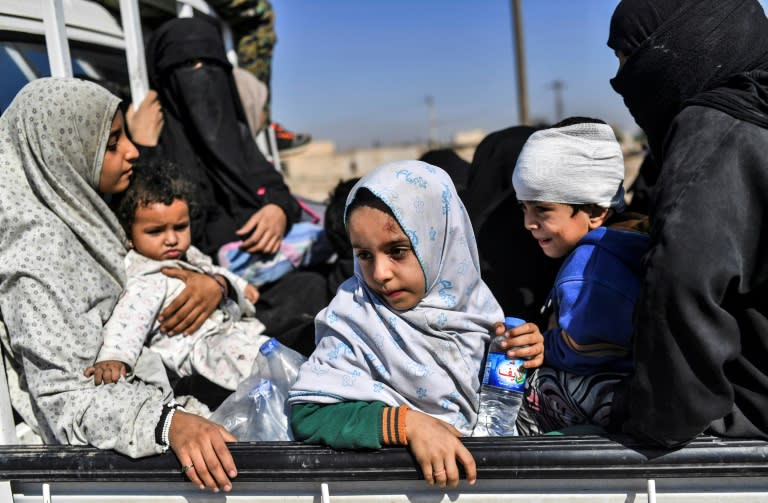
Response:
[608,0,768,447]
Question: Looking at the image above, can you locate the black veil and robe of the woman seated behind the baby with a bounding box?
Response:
[147,18,301,254]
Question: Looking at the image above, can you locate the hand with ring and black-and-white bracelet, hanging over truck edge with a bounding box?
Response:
[168,410,237,492]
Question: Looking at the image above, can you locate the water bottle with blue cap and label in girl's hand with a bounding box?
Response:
[472,316,525,437]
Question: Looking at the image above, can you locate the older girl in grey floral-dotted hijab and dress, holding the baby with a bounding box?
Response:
[0,78,236,490]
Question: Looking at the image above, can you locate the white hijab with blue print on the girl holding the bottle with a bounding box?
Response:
[289,161,503,435]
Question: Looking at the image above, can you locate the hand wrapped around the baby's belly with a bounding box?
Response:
[158,267,223,335]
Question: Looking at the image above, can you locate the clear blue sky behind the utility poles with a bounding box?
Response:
[272,0,637,149]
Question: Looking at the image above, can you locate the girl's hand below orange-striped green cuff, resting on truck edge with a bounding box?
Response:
[405,409,477,487]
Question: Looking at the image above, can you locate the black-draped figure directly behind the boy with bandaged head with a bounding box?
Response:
[462,126,562,326]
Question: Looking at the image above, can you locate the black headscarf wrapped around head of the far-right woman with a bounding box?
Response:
[608,0,768,160]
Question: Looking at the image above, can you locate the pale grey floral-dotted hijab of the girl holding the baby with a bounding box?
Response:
[0,78,125,432]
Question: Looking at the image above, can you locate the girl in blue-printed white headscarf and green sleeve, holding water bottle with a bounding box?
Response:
[289,161,543,486]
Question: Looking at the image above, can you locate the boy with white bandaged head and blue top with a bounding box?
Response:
[512,117,648,434]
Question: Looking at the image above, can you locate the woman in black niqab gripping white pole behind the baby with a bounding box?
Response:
[139,18,328,362]
